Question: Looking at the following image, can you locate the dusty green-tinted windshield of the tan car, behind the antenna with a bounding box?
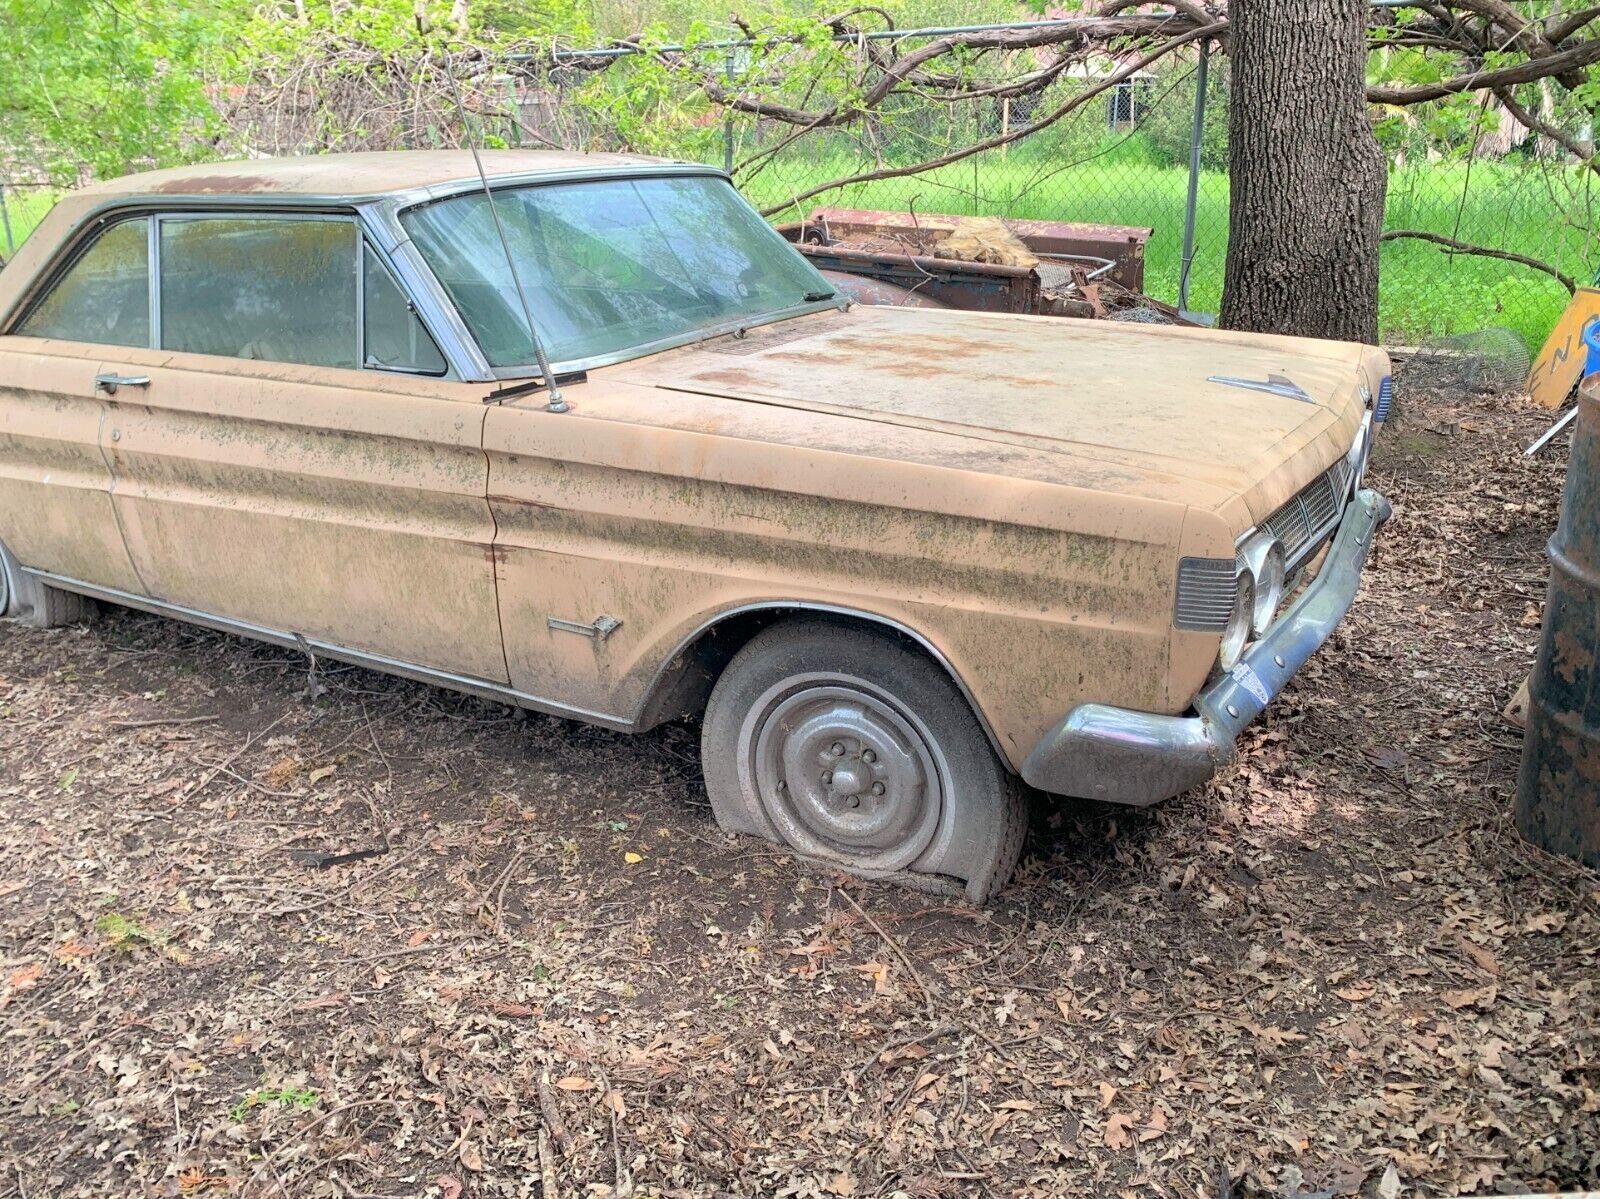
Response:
[400,176,832,367]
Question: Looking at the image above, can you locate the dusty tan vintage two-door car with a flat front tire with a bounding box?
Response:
[0,150,1389,901]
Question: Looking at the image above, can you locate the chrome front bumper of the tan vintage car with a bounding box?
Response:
[1022,488,1390,807]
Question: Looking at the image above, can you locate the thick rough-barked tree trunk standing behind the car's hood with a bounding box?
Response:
[1221,0,1389,341]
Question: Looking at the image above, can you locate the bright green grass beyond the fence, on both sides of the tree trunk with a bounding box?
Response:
[746,146,1600,347]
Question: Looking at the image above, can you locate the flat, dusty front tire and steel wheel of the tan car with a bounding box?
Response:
[701,620,1027,903]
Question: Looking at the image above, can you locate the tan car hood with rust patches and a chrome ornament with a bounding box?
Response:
[604,307,1366,520]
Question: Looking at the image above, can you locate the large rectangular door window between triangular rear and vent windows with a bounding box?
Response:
[158,216,362,367]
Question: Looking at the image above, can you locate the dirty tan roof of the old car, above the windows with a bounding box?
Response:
[74,150,664,200]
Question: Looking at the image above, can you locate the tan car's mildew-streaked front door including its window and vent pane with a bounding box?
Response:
[89,211,506,684]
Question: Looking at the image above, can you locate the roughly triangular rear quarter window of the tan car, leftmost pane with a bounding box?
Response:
[16,216,150,346]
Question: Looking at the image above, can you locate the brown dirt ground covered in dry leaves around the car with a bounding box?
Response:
[0,366,1600,1199]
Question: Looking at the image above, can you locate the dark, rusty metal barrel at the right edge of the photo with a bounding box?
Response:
[1517,375,1600,866]
